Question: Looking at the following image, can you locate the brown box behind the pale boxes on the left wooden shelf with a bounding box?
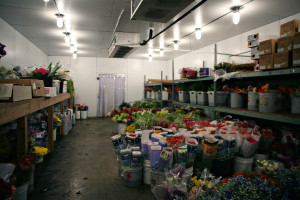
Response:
[0,79,45,97]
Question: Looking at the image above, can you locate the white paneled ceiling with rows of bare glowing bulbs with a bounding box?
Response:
[0,0,300,60]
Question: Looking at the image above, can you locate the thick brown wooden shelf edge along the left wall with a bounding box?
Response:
[0,93,70,125]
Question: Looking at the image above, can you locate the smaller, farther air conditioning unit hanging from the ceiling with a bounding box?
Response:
[108,32,140,58]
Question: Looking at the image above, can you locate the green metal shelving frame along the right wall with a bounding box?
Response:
[172,44,300,125]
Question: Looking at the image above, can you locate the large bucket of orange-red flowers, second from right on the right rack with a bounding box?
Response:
[259,90,277,113]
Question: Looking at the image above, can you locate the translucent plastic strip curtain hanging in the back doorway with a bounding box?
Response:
[97,74,125,117]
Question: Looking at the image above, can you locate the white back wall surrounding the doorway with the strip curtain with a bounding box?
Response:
[49,56,167,117]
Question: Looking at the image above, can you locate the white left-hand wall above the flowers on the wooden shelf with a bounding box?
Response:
[0,18,48,68]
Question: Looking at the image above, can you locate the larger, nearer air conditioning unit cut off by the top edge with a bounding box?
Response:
[130,0,195,23]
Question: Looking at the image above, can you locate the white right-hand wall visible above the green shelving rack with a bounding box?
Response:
[167,13,300,79]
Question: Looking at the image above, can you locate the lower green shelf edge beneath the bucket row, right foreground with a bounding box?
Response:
[215,106,300,125]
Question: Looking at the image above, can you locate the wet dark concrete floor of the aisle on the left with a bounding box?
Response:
[28,118,155,200]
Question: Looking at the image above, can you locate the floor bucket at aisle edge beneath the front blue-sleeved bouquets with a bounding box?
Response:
[122,167,143,187]
